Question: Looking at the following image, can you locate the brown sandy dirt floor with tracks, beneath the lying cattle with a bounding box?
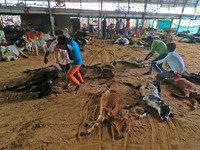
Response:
[0,39,200,150]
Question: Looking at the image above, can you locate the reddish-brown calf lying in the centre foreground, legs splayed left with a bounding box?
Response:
[80,88,129,137]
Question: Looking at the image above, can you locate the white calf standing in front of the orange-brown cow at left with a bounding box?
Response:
[26,40,48,56]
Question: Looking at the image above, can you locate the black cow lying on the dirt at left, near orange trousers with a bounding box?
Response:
[1,65,59,97]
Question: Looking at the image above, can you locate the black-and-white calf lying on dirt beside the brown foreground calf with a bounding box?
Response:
[123,82,173,121]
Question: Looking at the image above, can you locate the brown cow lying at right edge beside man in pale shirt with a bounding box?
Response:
[165,78,200,109]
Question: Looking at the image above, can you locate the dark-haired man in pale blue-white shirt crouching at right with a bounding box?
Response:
[152,43,185,92]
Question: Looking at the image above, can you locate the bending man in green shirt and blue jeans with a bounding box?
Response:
[144,36,167,75]
